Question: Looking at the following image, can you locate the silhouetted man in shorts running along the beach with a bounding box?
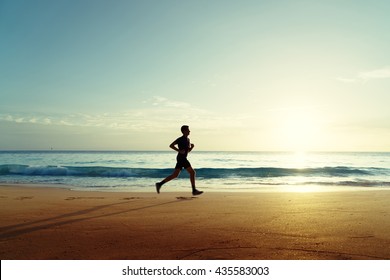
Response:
[156,125,203,195]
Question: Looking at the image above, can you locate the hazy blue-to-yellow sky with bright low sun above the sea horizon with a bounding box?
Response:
[0,0,390,151]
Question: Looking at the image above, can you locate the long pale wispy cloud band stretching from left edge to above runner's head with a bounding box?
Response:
[0,99,247,133]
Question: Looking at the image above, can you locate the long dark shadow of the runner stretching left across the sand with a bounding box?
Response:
[0,197,192,240]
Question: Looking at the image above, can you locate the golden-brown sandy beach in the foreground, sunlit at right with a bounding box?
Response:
[0,185,390,260]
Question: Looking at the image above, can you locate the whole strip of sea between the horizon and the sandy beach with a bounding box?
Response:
[0,151,390,192]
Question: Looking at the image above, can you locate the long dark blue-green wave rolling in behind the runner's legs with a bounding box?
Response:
[0,164,388,179]
